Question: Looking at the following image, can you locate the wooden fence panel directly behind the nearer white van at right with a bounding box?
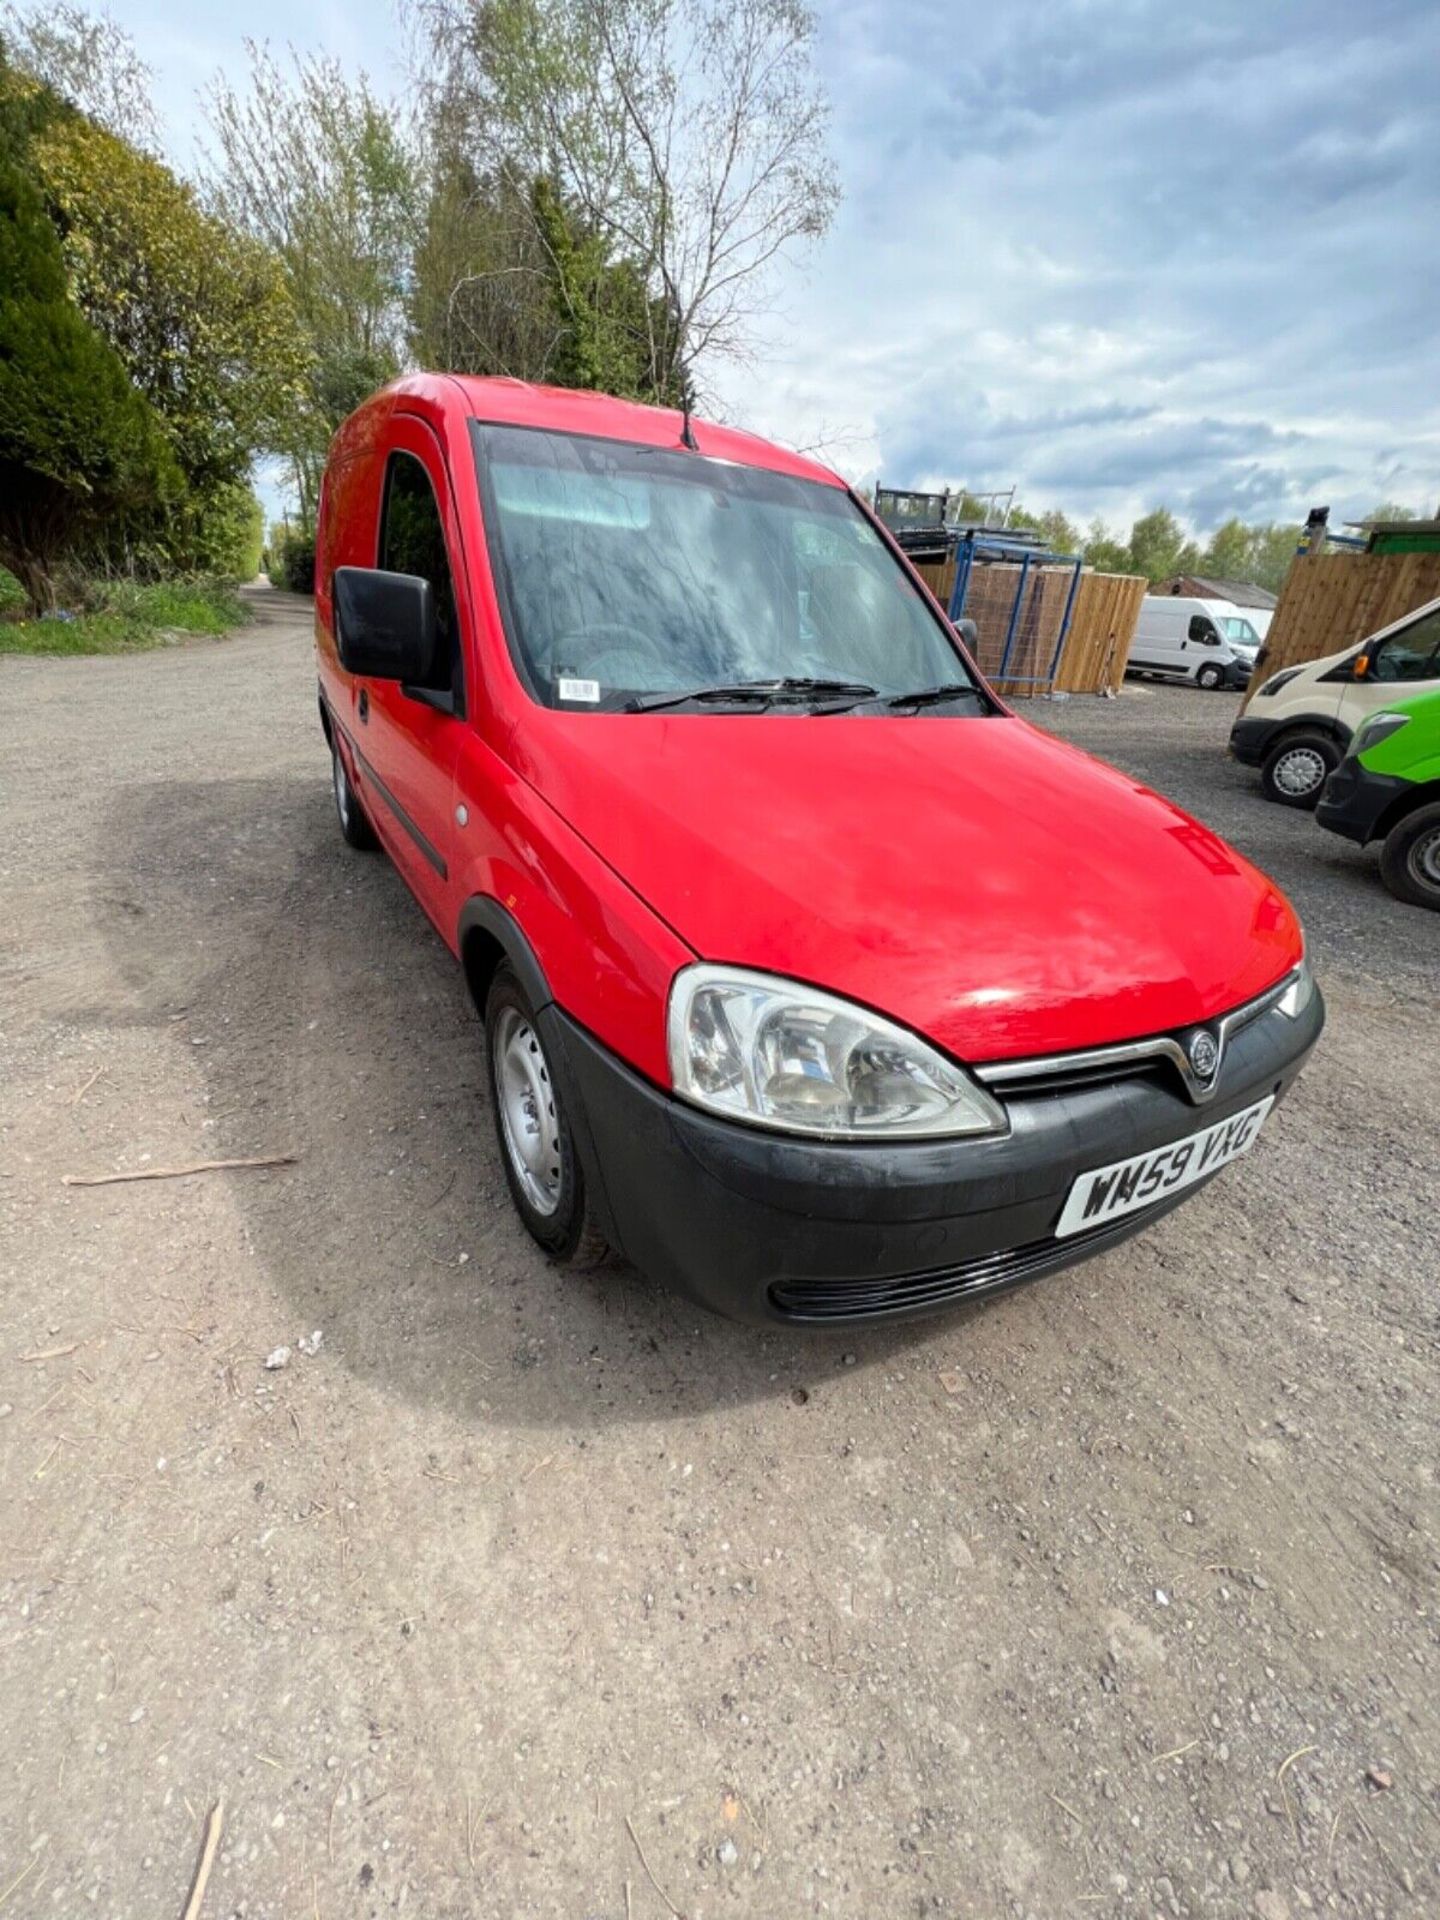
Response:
[1246,553,1440,703]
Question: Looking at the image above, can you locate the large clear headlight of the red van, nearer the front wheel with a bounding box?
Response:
[668,962,1008,1140]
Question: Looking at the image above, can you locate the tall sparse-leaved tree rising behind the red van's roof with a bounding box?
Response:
[401,0,839,392]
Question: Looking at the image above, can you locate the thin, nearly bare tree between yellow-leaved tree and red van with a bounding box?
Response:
[205,42,420,520]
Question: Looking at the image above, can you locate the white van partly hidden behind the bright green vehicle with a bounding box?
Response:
[1231,591,1440,806]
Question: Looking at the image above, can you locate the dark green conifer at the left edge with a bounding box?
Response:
[0,69,182,612]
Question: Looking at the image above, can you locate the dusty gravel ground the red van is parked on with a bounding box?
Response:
[0,595,1440,1920]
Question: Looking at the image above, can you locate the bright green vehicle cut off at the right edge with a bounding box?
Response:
[1315,693,1440,910]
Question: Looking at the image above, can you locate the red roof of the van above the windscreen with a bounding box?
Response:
[359,372,845,488]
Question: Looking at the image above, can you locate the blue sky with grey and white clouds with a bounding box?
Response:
[113,0,1440,530]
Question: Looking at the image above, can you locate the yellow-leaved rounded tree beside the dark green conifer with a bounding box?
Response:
[31,96,305,564]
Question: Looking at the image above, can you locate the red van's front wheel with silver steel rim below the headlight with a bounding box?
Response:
[486,964,607,1265]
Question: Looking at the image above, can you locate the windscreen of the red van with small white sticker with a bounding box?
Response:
[472,422,972,712]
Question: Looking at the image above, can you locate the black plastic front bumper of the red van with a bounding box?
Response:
[540,989,1325,1325]
